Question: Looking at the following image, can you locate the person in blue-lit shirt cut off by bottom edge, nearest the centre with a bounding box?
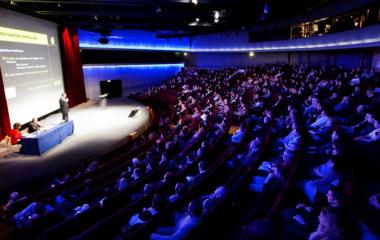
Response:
[150,201,202,240]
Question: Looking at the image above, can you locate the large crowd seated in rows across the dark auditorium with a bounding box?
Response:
[2,64,380,240]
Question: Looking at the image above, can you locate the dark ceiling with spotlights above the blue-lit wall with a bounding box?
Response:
[2,0,331,35]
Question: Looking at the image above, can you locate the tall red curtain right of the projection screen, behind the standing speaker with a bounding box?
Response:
[61,27,86,107]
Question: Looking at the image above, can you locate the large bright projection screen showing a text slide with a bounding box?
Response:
[0,8,64,124]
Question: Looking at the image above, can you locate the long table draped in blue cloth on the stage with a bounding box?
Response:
[20,121,74,155]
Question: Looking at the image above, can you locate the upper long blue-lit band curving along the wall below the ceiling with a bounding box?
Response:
[79,24,380,52]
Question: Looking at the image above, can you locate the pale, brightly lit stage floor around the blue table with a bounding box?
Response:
[0,98,149,189]
